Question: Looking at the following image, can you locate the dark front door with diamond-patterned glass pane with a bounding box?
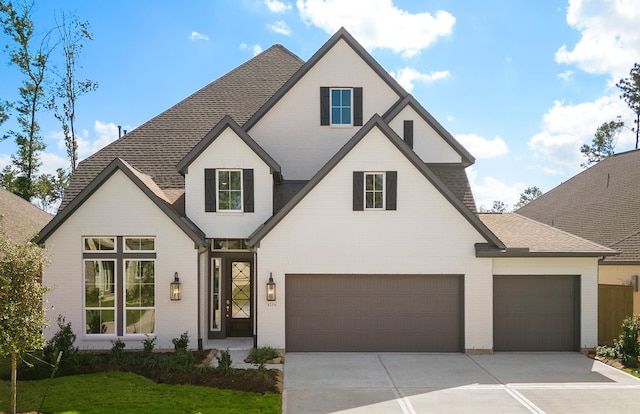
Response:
[225,258,253,336]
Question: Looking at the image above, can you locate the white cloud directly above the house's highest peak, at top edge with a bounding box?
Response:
[296,0,456,57]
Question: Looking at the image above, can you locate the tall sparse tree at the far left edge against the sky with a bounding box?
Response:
[0,0,53,201]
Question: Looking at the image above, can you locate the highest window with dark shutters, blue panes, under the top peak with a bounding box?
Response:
[320,86,363,126]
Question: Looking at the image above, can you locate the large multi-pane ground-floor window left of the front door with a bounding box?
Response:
[83,236,156,336]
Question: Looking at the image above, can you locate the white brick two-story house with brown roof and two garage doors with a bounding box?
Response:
[38,29,613,352]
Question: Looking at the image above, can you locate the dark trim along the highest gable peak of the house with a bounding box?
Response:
[242,27,407,131]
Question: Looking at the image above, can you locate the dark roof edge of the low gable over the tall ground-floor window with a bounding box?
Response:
[35,158,207,247]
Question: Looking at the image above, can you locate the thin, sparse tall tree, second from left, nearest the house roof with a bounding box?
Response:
[49,13,98,174]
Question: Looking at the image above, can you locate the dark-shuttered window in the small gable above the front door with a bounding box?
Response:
[204,168,254,213]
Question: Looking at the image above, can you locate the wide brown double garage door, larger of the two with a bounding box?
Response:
[285,275,464,352]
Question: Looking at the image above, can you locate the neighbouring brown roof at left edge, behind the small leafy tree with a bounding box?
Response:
[0,188,53,243]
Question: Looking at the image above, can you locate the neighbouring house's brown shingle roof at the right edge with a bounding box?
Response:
[517,150,640,263]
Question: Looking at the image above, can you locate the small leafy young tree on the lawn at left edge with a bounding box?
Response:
[0,238,48,413]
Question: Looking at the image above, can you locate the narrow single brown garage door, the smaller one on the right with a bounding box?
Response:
[493,276,580,351]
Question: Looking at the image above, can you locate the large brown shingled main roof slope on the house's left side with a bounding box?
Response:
[59,45,304,211]
